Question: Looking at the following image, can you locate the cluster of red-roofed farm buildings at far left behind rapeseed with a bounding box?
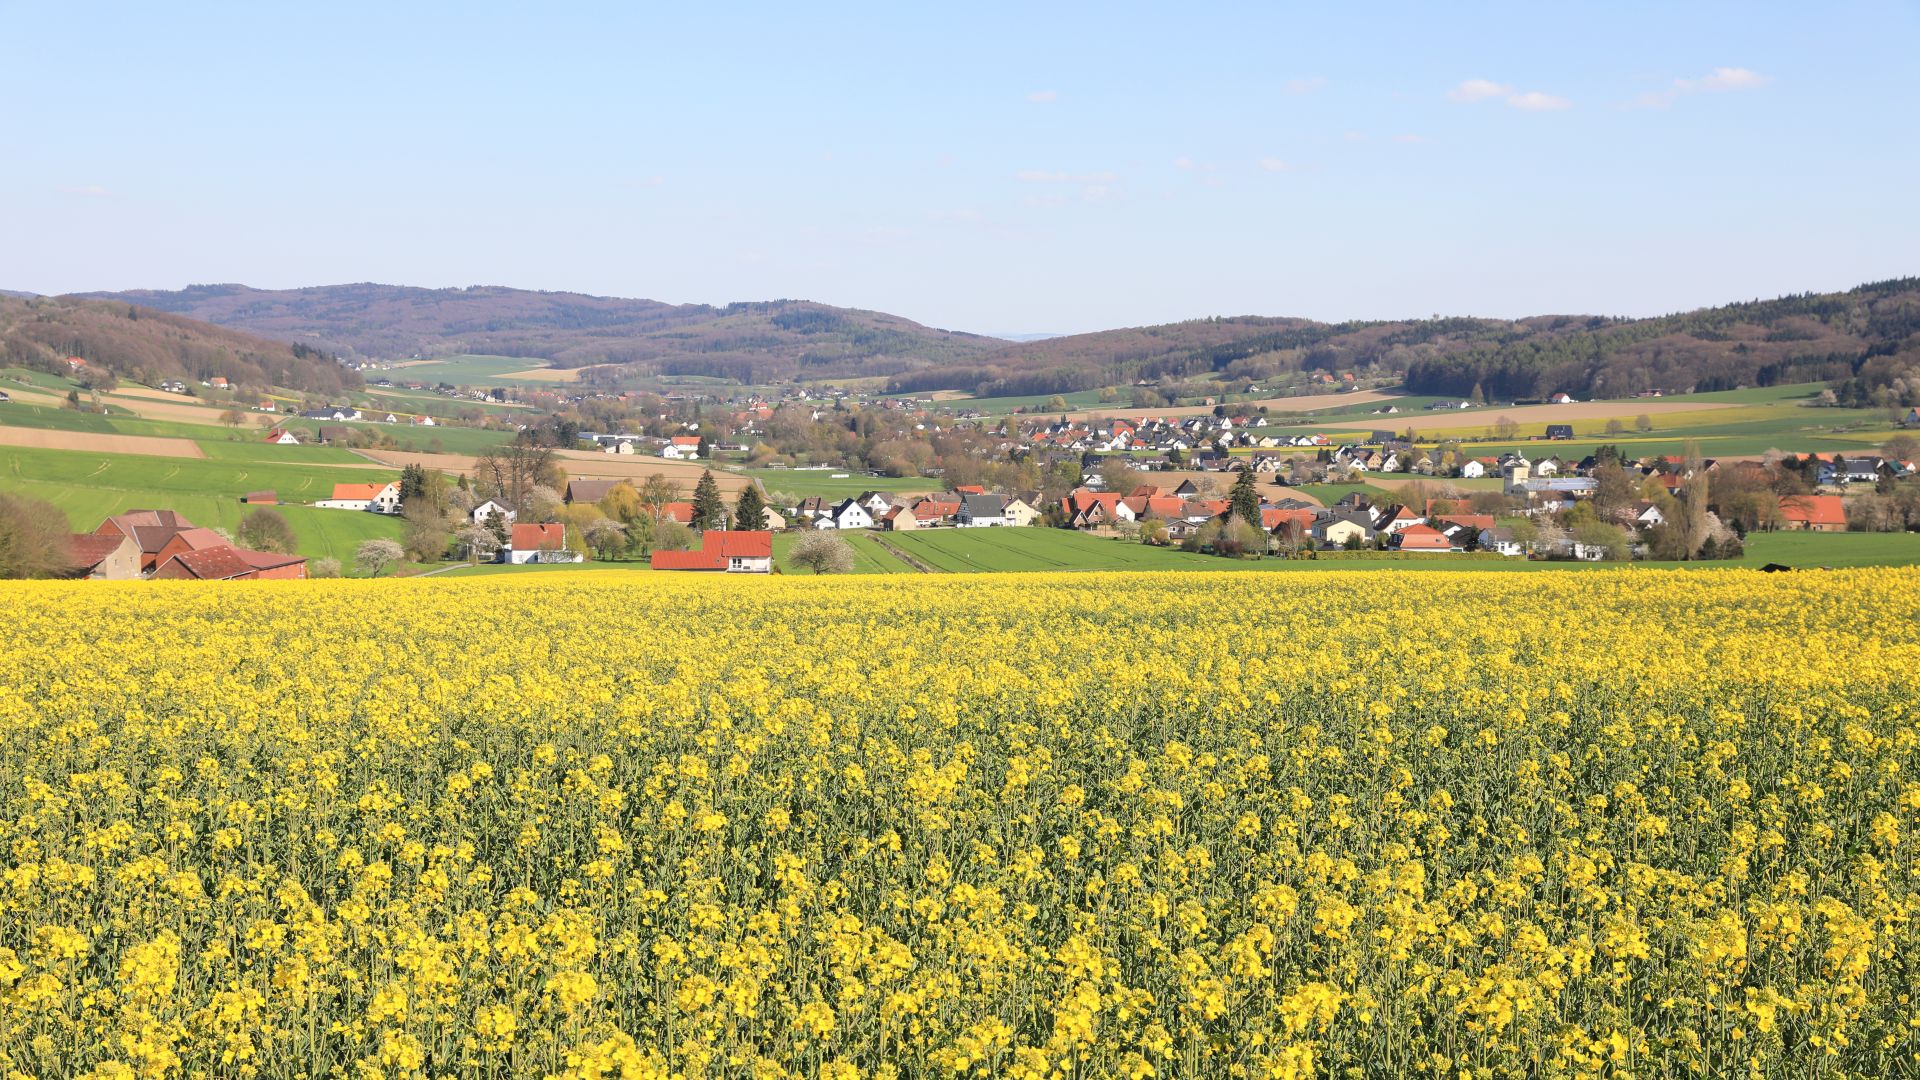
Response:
[67,509,307,580]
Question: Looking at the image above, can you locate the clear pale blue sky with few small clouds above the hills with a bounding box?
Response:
[0,2,1920,332]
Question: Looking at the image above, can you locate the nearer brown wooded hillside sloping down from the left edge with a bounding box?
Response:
[0,296,361,396]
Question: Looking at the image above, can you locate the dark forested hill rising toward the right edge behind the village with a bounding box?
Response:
[891,279,1920,400]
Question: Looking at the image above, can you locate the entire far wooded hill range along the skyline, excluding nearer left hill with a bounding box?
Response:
[71,279,1920,404]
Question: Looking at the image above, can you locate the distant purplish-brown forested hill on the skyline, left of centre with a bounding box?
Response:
[71,284,1006,382]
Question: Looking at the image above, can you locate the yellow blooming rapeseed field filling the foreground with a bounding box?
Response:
[0,571,1920,1080]
